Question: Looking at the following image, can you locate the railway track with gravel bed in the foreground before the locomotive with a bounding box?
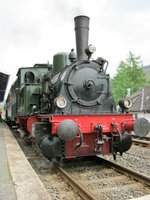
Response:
[55,157,150,200]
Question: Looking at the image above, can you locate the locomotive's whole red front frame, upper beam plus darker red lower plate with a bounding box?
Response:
[20,114,134,158]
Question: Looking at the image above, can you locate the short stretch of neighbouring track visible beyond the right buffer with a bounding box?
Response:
[132,135,150,148]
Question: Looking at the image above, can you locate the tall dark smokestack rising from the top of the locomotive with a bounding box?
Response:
[74,15,90,61]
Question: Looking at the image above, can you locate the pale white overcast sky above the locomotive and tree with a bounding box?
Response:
[0,0,150,86]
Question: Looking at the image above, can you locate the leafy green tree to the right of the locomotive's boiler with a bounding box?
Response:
[112,52,146,103]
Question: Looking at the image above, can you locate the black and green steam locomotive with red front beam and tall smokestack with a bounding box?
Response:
[5,16,150,162]
